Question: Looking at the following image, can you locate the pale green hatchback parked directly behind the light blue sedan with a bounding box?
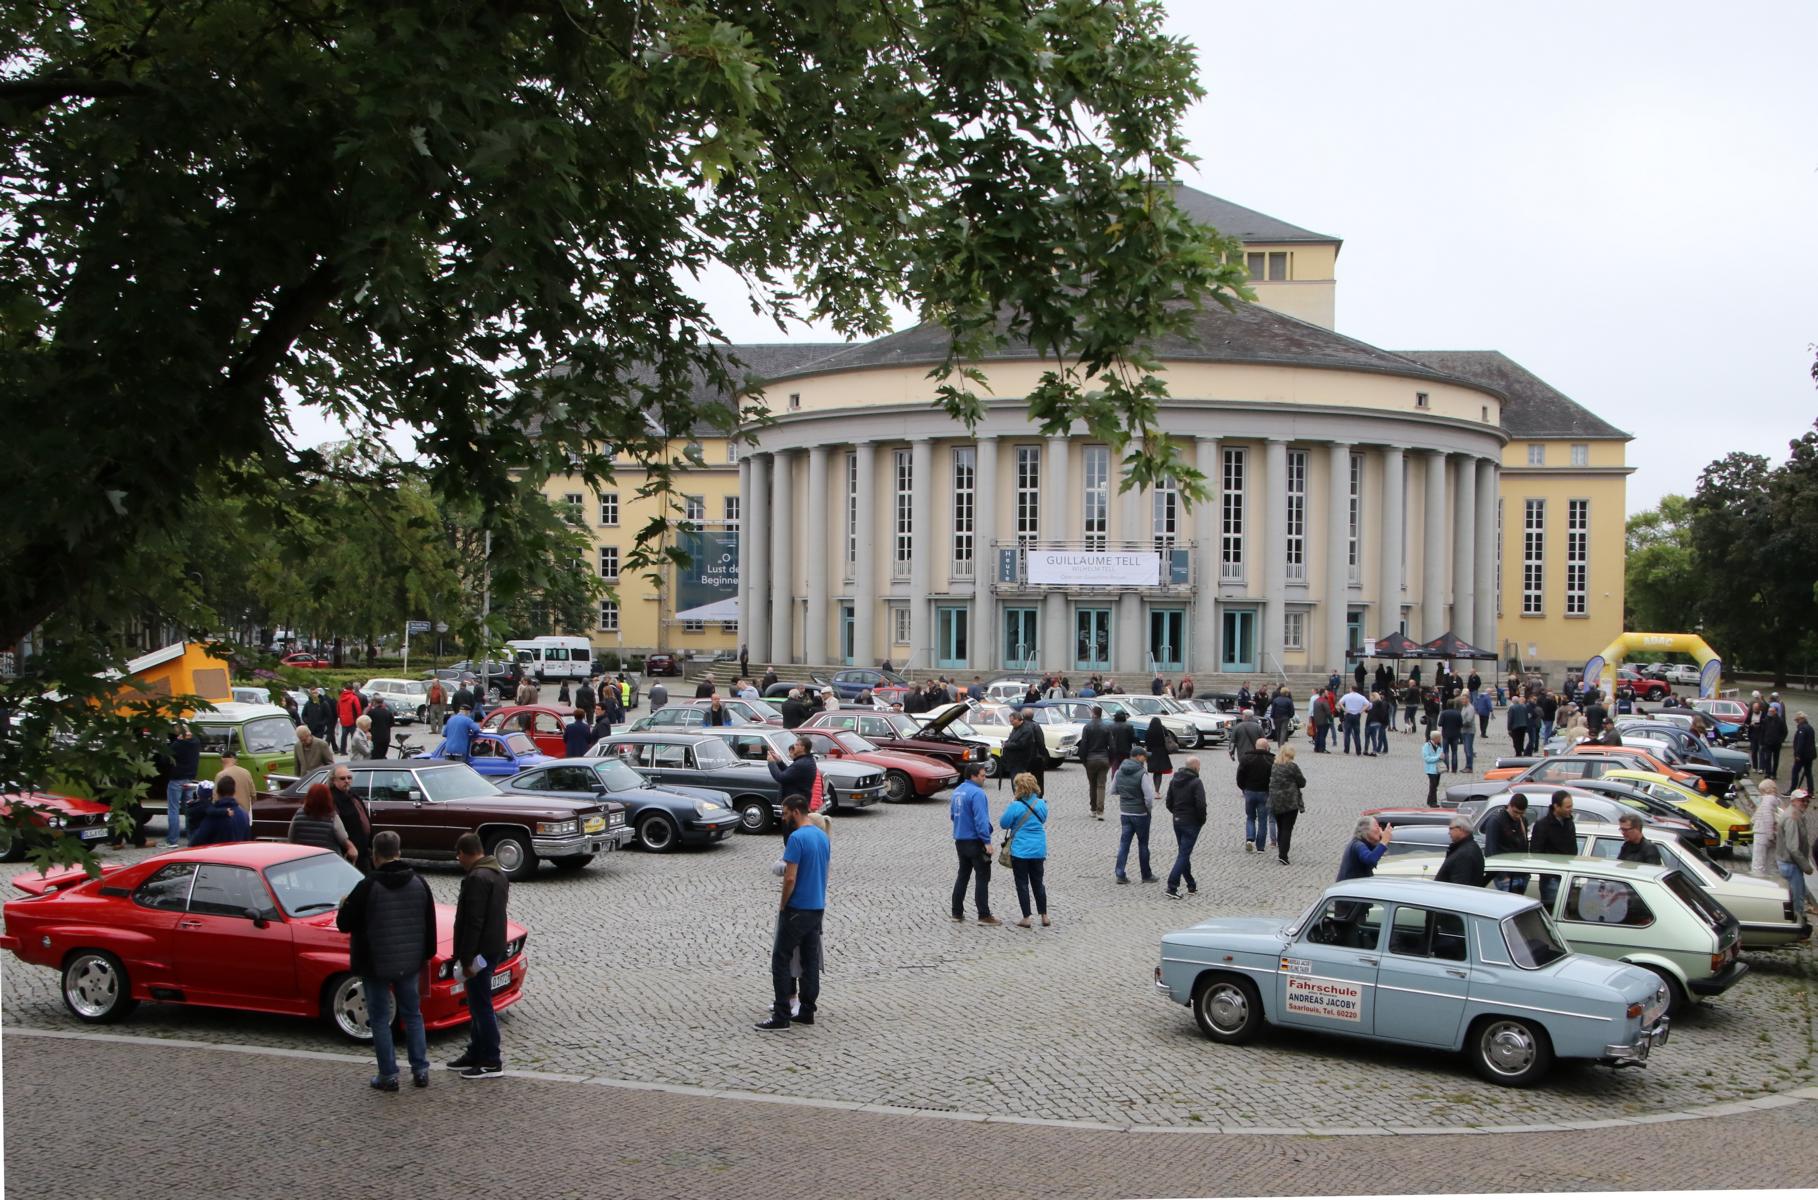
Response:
[1376,855,1749,1016]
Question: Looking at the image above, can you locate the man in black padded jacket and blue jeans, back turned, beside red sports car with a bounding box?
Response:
[335,829,436,1091]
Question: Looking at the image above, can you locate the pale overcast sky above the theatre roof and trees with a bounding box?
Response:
[298,0,1818,511]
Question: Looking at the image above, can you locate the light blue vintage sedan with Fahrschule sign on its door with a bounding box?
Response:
[1154,878,1667,1087]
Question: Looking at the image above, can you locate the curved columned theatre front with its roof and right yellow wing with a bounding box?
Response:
[551,189,1629,675]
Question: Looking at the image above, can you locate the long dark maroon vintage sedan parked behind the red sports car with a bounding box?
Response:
[253,758,631,880]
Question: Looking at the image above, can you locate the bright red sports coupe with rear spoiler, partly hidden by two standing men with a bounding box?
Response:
[0,842,525,1042]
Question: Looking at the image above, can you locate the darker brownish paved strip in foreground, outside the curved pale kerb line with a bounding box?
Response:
[4,1036,1818,1200]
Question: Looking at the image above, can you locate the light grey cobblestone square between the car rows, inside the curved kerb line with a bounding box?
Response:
[0,709,1818,1141]
